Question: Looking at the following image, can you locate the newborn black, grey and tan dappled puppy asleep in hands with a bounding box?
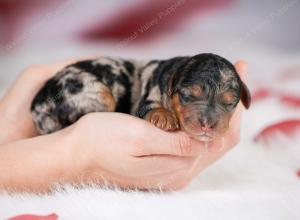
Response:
[31,54,251,141]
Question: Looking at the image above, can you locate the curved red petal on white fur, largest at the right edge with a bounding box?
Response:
[254,119,300,142]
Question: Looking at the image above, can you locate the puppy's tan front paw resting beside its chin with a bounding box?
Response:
[146,108,179,131]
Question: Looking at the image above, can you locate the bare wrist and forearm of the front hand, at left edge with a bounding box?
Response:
[0,125,82,192]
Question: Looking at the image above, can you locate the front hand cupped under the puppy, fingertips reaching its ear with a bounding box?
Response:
[72,61,246,190]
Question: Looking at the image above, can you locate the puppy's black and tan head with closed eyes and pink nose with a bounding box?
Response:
[168,54,251,141]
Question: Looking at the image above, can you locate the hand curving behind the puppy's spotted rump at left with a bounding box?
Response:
[0,59,75,145]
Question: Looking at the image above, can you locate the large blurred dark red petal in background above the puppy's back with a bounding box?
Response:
[82,0,233,42]
